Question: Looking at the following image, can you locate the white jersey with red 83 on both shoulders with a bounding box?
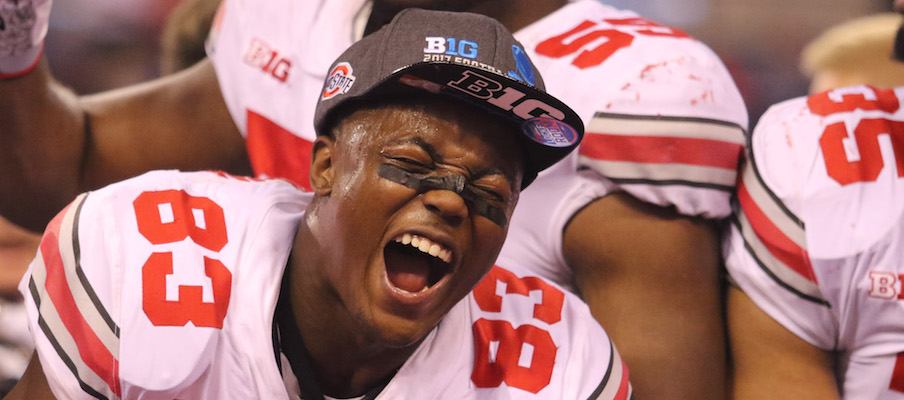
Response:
[20,171,631,400]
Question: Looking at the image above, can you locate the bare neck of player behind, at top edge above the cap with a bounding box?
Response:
[364,0,568,35]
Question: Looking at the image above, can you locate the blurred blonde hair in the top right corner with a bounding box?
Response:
[801,12,904,78]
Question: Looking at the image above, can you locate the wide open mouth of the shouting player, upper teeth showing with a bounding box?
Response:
[383,233,452,293]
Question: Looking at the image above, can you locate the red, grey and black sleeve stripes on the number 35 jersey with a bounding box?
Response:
[733,151,829,306]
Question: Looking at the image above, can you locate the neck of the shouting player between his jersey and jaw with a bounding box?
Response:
[288,223,417,398]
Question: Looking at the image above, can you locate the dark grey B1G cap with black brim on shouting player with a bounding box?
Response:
[314,8,584,189]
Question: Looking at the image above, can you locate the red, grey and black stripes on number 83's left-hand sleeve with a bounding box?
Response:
[29,194,121,398]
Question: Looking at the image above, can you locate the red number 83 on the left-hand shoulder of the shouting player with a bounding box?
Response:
[132,190,232,328]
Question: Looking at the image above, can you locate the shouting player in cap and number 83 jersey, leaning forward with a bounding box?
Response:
[7,10,630,399]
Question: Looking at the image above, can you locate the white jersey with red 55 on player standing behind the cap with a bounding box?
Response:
[208,0,747,290]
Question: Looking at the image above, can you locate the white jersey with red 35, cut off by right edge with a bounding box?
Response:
[723,86,904,400]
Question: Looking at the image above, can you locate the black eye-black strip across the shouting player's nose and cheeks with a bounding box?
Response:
[377,164,508,226]
